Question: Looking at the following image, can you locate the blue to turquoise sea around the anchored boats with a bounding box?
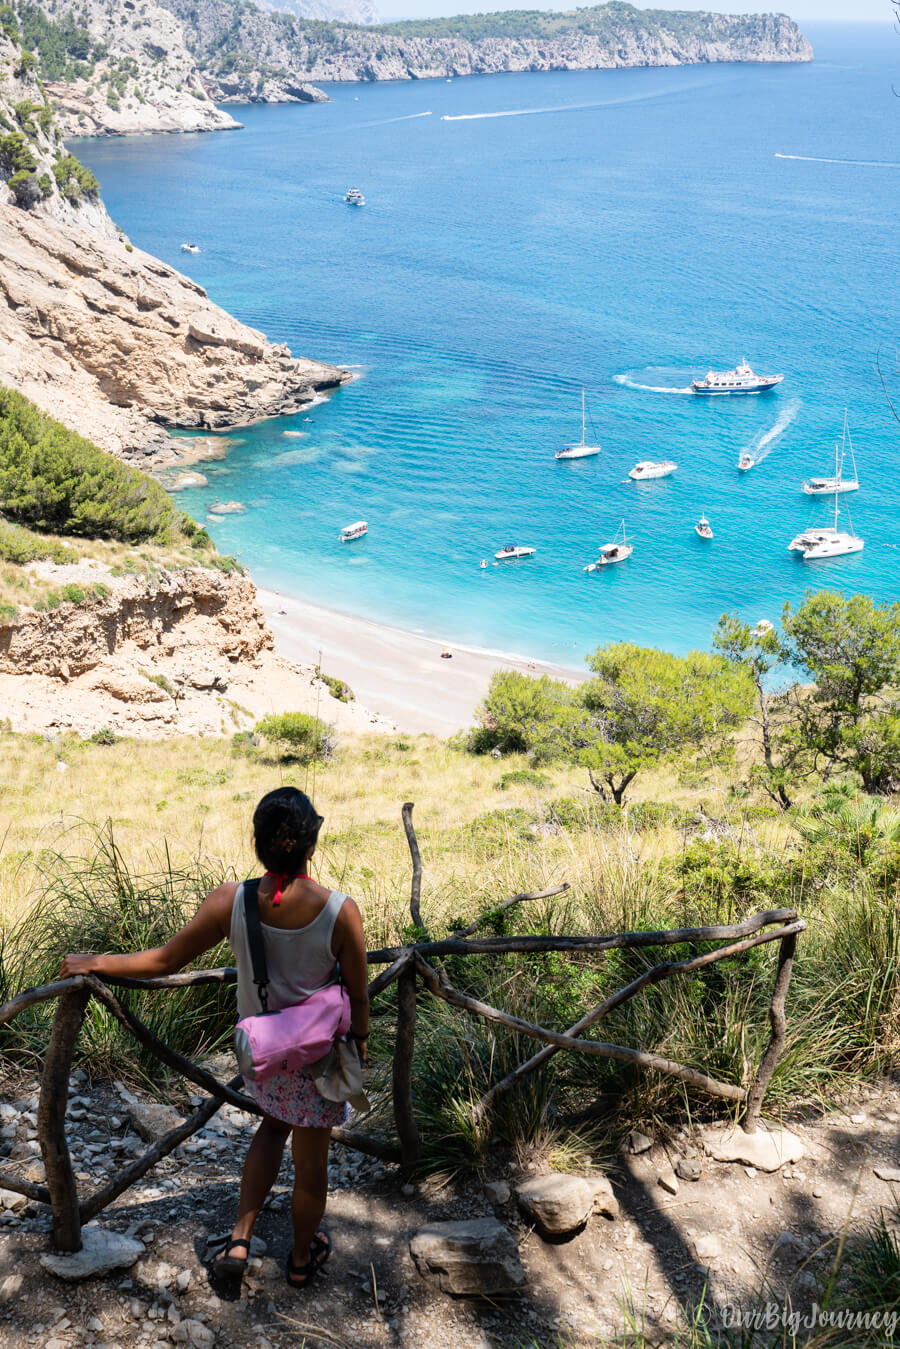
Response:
[78,26,900,664]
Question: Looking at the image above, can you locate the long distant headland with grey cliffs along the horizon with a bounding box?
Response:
[163,0,812,81]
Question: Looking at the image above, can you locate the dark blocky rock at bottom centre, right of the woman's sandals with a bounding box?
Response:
[409,1218,526,1296]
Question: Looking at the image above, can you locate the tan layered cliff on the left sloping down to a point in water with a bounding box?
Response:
[0,32,349,467]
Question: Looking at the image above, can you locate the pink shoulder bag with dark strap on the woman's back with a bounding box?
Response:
[235,881,349,1082]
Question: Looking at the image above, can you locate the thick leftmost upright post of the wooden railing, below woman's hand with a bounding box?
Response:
[38,986,90,1252]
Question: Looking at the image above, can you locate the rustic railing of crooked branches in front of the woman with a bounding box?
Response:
[0,803,806,1251]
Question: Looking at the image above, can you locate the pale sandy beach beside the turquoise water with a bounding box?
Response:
[258,590,584,735]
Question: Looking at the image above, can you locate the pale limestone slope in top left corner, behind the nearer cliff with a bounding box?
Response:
[4,0,239,136]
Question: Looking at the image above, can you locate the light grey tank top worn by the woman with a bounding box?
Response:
[228,882,347,1018]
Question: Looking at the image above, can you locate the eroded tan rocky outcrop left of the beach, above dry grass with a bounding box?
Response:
[0,563,390,738]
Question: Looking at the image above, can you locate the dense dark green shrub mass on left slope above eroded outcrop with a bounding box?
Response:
[0,387,190,544]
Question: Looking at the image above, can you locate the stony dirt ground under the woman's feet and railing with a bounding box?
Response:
[0,1070,900,1349]
